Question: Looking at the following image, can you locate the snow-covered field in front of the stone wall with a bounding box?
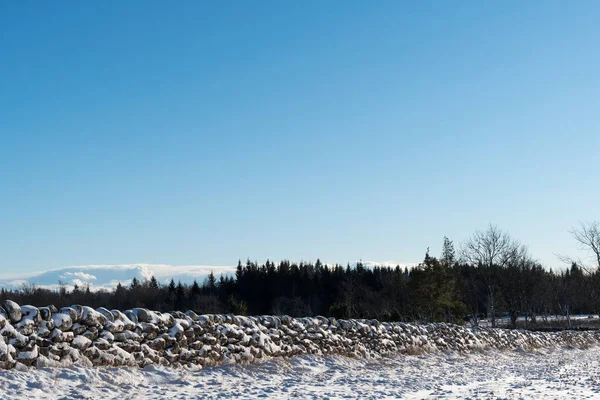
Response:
[0,347,600,400]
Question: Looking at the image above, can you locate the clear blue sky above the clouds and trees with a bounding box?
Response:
[0,0,600,273]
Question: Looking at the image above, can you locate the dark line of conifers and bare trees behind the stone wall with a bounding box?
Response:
[0,222,600,326]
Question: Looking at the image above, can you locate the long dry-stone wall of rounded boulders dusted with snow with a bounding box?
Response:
[0,301,600,369]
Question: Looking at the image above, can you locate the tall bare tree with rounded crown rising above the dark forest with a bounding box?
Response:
[461,224,527,327]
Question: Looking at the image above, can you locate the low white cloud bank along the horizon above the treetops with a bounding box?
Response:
[0,261,416,291]
